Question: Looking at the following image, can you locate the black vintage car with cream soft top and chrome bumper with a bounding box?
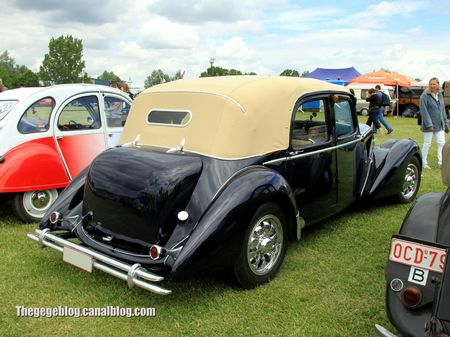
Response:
[29,76,422,294]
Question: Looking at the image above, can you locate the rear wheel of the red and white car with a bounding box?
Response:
[13,189,58,222]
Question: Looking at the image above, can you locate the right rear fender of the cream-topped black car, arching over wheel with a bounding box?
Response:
[172,166,301,279]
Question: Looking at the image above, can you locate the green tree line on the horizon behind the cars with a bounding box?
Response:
[0,35,309,88]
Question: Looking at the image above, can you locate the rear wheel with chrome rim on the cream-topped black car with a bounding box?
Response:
[232,203,287,289]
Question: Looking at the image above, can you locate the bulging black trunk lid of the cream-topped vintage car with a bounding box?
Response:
[83,147,202,253]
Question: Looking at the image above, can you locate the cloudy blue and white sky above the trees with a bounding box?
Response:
[0,0,450,88]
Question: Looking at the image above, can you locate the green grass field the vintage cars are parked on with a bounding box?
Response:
[0,117,445,337]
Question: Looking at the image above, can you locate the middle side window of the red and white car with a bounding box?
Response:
[58,96,102,131]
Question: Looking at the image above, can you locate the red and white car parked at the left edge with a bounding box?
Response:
[0,84,131,222]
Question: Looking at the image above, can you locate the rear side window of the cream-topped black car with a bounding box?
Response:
[291,99,330,148]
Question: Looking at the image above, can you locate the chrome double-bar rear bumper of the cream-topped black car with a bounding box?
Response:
[27,228,172,295]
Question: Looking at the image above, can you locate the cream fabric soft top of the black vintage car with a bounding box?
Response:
[120,76,347,159]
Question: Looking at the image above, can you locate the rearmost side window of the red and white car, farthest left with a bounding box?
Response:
[17,97,55,134]
